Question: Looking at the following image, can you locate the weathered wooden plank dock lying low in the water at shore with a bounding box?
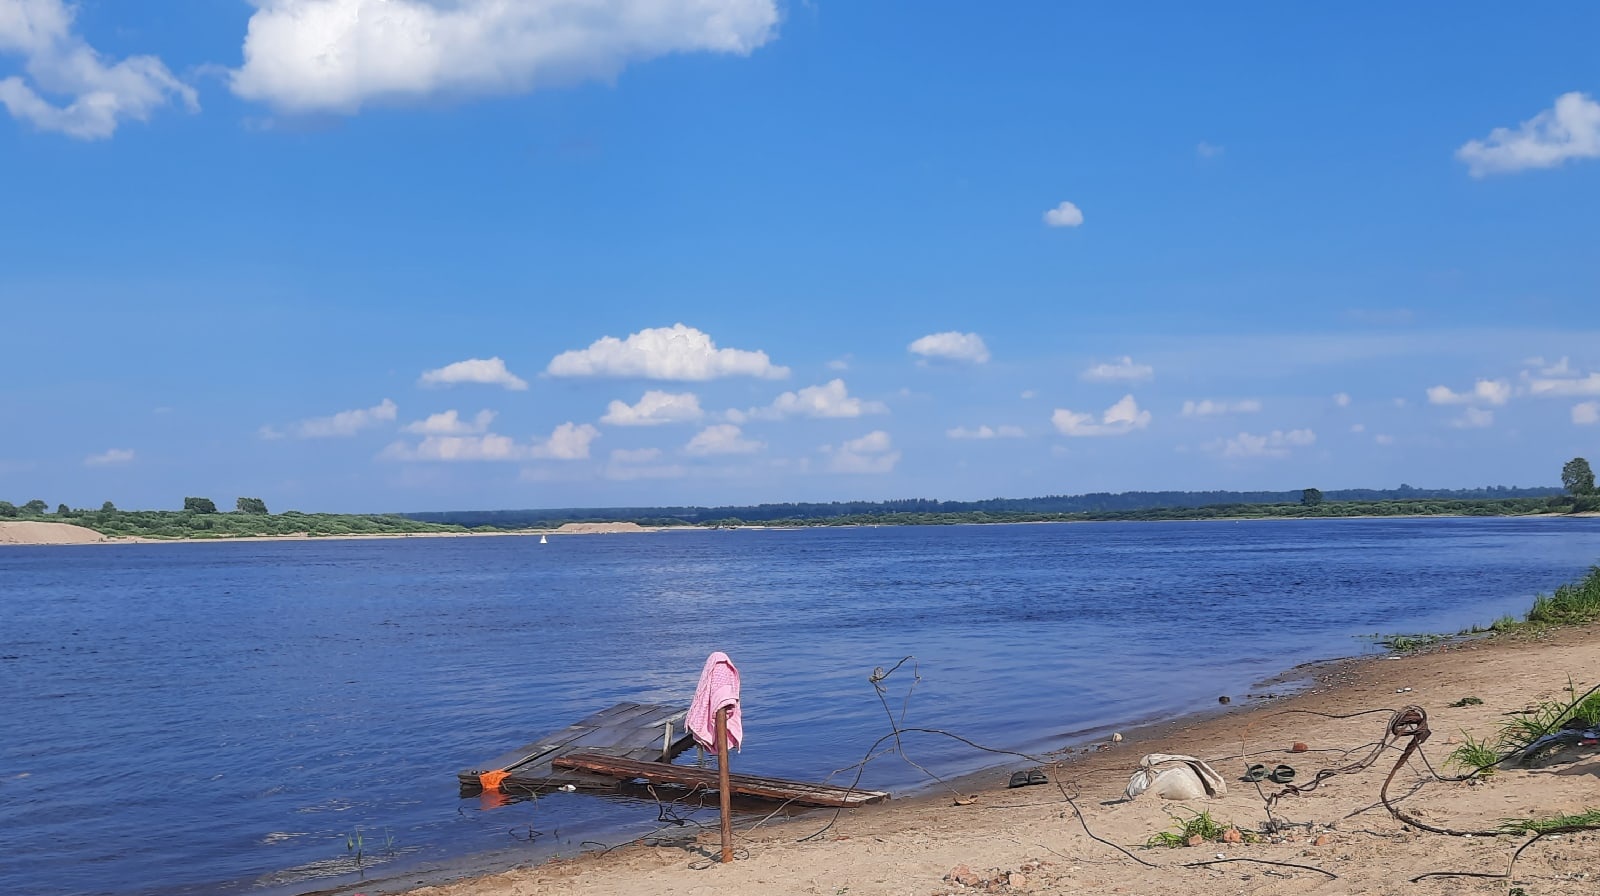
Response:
[456,702,890,808]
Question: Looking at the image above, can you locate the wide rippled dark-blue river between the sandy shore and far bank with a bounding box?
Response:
[9,518,1600,896]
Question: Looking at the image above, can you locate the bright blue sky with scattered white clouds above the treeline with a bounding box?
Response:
[0,0,1600,510]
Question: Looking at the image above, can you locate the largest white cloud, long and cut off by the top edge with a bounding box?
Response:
[232,0,779,114]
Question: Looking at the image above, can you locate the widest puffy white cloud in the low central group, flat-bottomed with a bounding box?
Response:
[546,323,789,381]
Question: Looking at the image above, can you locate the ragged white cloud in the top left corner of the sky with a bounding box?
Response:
[0,0,200,139]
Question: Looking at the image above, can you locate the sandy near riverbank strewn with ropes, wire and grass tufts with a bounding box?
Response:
[390,626,1600,896]
